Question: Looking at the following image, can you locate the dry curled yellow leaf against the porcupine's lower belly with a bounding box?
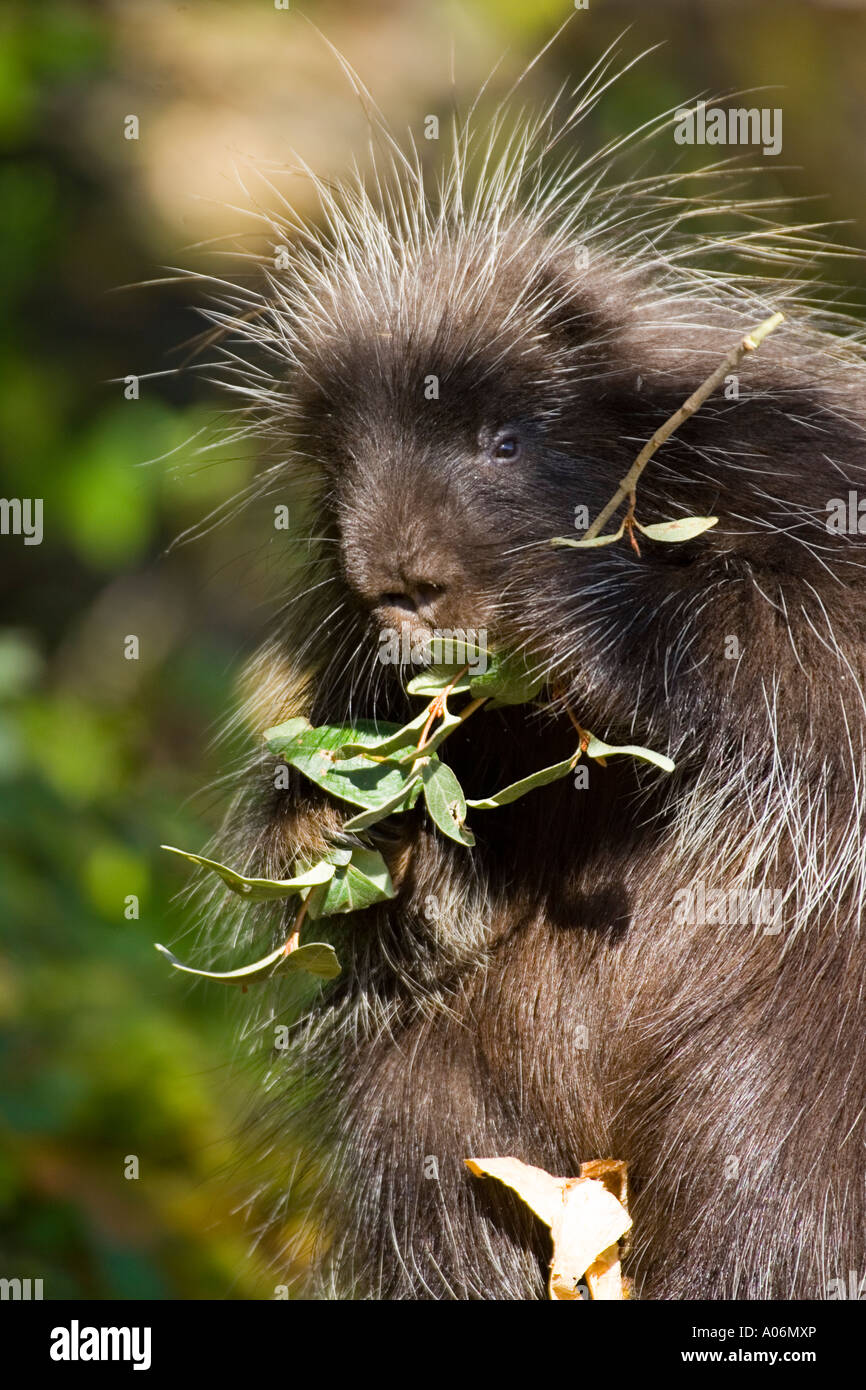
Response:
[464,1158,631,1301]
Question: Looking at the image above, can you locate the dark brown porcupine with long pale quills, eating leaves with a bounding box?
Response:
[183,46,866,1300]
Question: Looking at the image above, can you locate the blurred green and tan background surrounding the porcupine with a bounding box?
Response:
[0,0,866,1298]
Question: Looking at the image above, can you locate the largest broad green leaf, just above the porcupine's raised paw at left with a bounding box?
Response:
[265,720,420,810]
